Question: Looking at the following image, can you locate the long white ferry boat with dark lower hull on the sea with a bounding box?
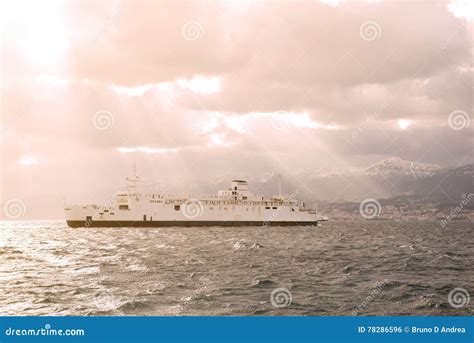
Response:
[64,171,318,227]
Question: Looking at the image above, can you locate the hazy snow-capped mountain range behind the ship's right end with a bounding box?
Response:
[234,157,474,203]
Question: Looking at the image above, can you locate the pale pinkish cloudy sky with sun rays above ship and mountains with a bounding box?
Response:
[0,0,474,218]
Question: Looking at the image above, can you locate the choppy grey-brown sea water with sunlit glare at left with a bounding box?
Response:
[0,221,474,315]
